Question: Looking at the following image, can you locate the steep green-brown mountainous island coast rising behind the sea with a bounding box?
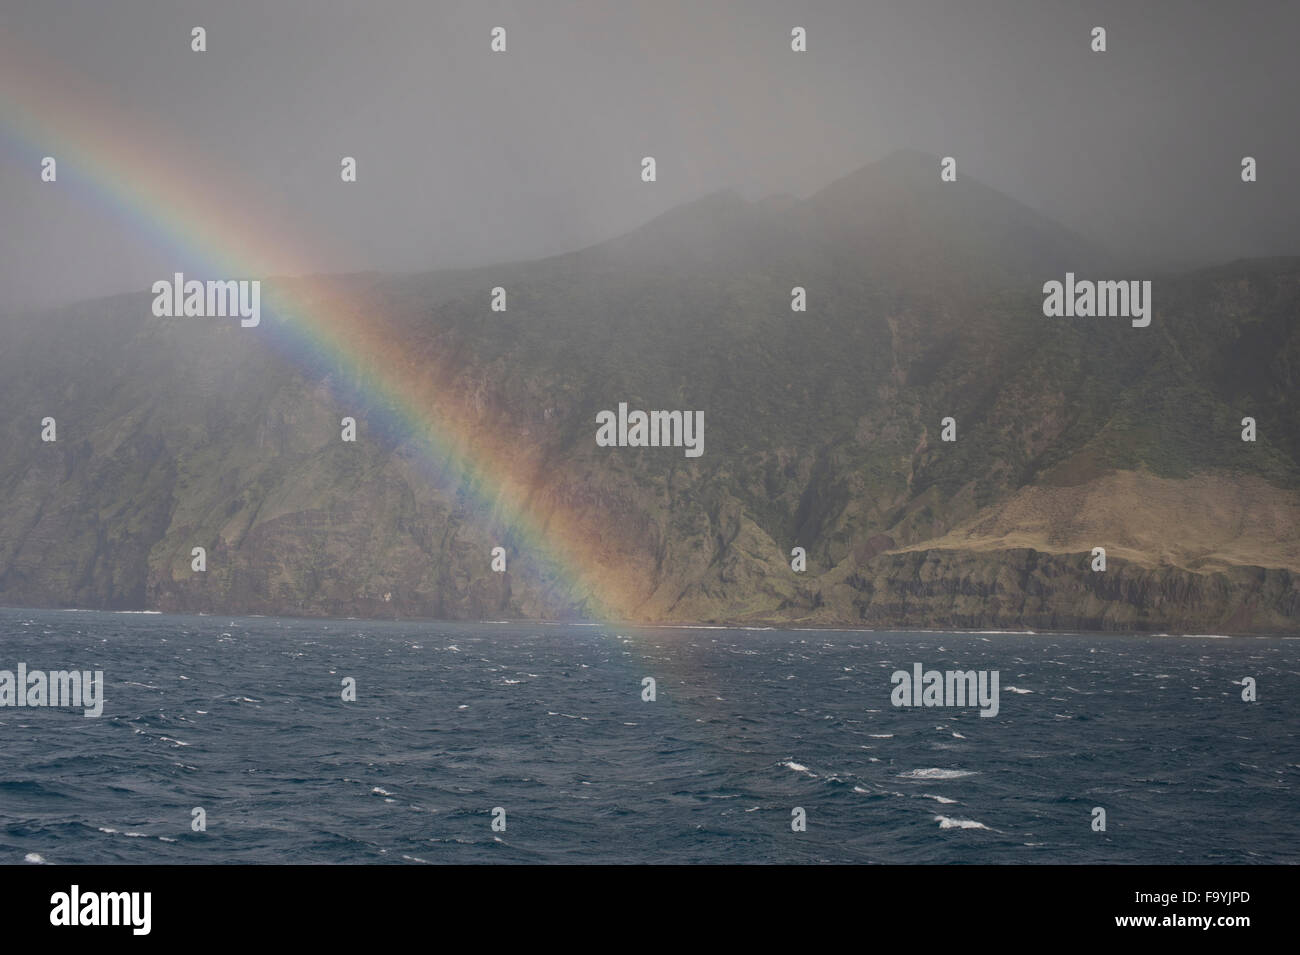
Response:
[0,155,1300,633]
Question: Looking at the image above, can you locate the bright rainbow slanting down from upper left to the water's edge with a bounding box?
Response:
[0,39,640,621]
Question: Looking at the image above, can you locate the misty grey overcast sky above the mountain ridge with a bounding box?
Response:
[0,0,1300,309]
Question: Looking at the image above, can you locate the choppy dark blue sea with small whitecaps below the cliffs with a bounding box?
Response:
[0,609,1300,864]
